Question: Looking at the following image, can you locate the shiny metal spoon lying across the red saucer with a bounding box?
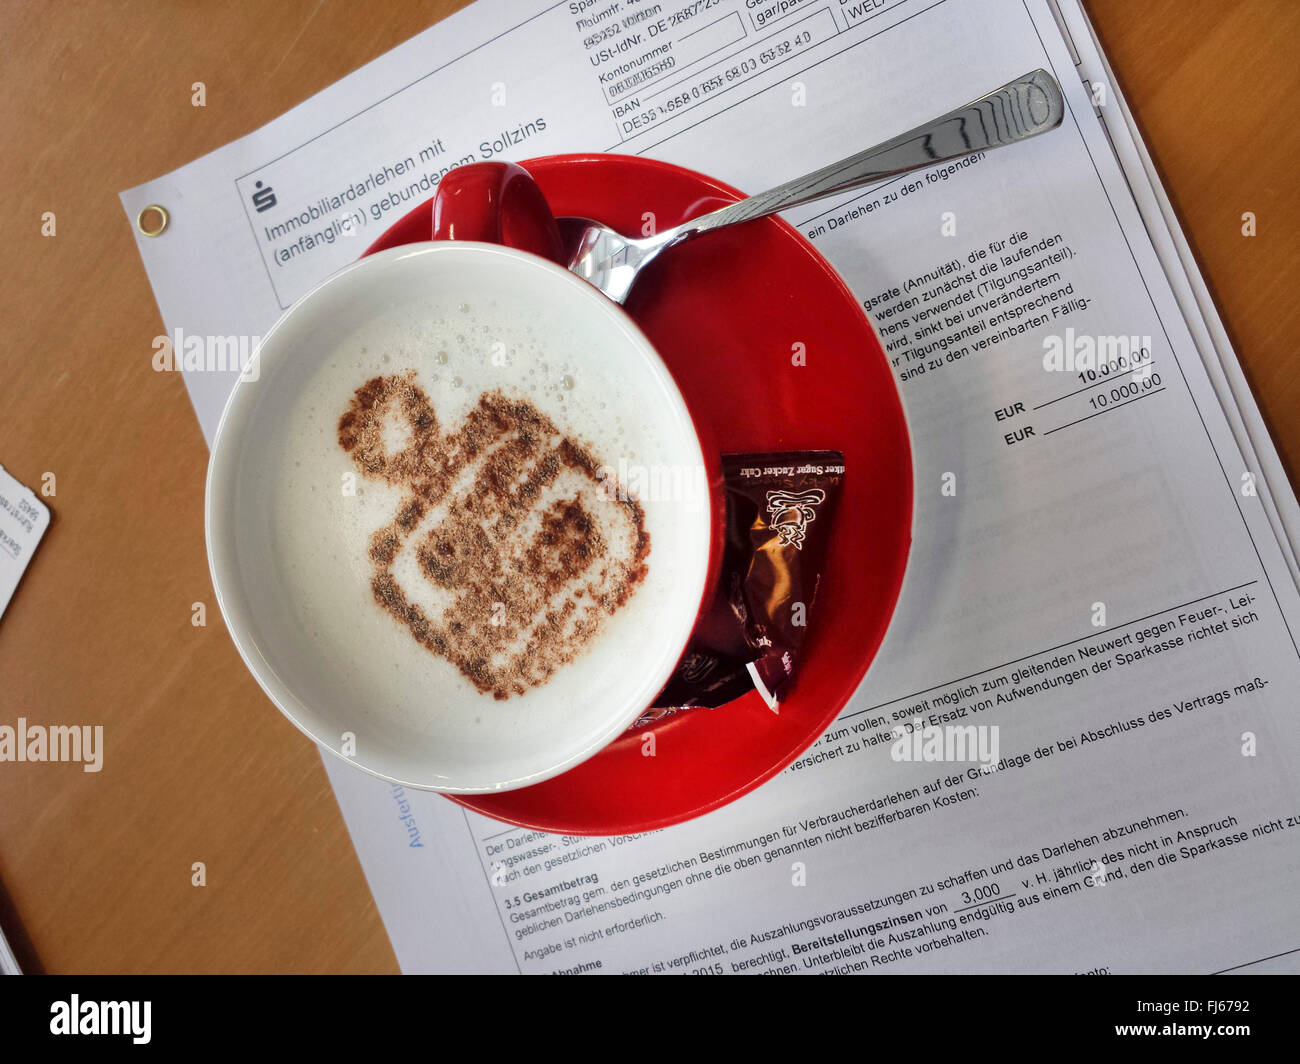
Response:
[556,70,1065,303]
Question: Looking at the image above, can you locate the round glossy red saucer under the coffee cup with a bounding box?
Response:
[367,155,913,835]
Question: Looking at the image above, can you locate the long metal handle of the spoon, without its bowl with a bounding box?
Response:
[670,70,1065,243]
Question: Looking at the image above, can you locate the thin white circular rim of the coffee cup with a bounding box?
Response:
[204,241,718,795]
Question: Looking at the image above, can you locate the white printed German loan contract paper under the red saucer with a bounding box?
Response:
[122,0,1300,973]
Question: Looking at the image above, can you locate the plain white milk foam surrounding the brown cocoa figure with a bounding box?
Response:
[270,298,701,743]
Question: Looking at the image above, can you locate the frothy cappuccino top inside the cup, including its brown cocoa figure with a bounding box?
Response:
[270,299,680,741]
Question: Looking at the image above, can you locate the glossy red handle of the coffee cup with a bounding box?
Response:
[433,163,563,265]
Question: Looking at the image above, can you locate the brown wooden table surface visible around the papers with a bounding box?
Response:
[0,0,1300,972]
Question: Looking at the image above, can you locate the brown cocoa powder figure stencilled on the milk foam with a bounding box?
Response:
[338,371,650,698]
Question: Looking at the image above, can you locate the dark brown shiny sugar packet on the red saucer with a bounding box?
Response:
[633,451,844,727]
